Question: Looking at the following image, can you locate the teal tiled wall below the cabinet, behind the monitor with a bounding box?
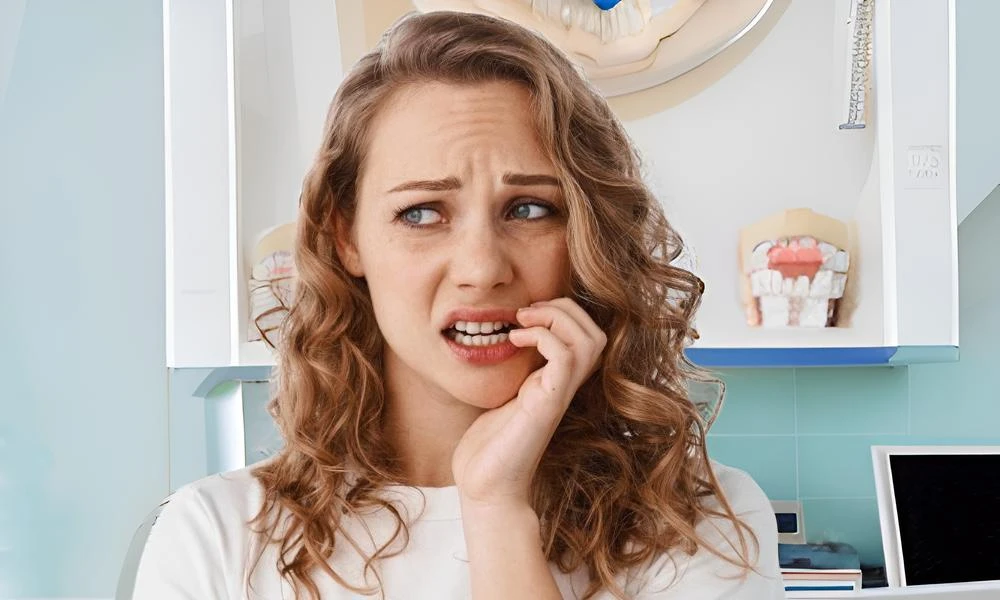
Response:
[709,191,1000,564]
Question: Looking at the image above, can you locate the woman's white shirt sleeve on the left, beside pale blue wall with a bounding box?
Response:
[132,488,228,600]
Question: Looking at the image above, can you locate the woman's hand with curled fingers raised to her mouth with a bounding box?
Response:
[451,298,607,511]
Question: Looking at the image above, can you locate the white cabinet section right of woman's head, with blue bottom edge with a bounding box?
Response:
[612,0,958,366]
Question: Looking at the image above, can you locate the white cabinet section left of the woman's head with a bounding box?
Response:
[164,0,342,367]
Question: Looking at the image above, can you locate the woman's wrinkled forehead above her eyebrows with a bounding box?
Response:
[365,81,551,183]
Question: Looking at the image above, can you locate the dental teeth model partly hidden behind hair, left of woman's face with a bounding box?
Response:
[247,224,296,348]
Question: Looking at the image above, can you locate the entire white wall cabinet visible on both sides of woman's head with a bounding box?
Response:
[164,0,958,367]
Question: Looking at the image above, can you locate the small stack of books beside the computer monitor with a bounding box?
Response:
[778,544,861,598]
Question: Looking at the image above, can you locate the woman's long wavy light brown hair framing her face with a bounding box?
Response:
[251,13,758,598]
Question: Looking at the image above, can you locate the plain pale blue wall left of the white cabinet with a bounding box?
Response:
[0,0,167,598]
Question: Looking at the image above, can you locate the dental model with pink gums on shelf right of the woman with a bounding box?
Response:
[741,209,851,327]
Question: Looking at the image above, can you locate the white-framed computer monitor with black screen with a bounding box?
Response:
[872,446,1000,587]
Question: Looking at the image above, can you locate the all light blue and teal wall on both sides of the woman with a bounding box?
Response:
[0,0,1000,598]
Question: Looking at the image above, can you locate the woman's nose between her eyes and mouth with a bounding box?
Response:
[450,219,514,290]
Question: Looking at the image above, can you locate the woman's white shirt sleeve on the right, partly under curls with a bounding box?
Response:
[635,465,785,600]
